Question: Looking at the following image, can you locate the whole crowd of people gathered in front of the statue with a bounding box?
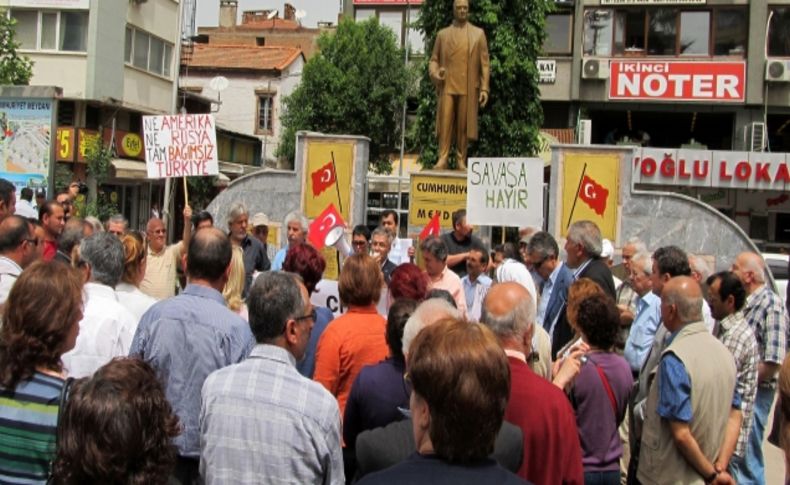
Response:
[0,179,790,485]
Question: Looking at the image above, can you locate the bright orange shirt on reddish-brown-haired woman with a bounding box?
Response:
[313,305,389,416]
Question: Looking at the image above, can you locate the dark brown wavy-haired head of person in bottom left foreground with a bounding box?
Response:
[54,358,180,485]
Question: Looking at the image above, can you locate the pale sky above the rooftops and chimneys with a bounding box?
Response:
[196,0,341,27]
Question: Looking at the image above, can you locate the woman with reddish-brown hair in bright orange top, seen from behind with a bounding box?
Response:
[313,250,389,416]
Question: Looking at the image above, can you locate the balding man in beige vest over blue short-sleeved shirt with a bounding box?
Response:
[637,276,741,484]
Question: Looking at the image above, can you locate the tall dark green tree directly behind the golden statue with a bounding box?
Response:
[409,0,553,167]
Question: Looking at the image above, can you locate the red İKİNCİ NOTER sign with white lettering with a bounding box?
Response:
[609,61,746,102]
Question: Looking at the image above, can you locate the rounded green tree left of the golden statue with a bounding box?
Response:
[277,18,408,171]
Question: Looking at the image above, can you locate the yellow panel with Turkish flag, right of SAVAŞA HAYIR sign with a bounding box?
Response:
[560,152,620,241]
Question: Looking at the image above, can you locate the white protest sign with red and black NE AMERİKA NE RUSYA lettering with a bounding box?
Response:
[143,114,219,179]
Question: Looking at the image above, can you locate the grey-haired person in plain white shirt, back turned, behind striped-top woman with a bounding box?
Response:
[63,232,137,378]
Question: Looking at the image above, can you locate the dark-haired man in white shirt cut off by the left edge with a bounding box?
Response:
[0,215,42,305]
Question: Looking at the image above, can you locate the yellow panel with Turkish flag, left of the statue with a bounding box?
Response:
[303,140,354,223]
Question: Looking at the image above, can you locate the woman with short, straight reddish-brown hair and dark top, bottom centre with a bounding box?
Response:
[359,319,528,485]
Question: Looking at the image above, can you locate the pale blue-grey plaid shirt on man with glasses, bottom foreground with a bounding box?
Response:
[200,344,345,485]
